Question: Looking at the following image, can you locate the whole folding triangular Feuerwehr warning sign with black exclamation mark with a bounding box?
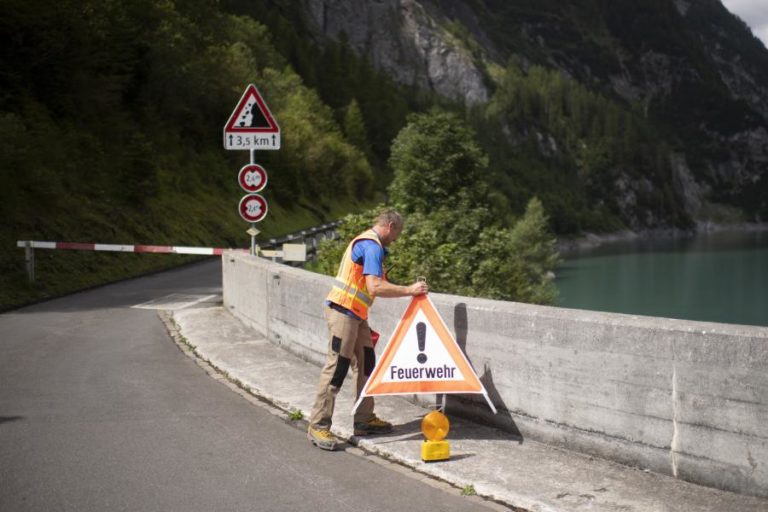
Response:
[353,295,496,413]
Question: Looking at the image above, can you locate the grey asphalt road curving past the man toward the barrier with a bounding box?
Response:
[0,260,492,512]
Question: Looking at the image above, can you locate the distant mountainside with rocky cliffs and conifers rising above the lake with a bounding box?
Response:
[286,0,768,233]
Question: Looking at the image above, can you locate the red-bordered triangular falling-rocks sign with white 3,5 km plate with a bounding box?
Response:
[224,84,280,150]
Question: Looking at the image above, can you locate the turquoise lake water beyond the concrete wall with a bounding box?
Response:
[555,231,768,326]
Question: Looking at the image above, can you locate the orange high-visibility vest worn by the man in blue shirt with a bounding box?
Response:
[326,229,386,320]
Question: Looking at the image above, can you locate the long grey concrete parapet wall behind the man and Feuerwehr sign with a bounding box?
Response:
[223,253,768,497]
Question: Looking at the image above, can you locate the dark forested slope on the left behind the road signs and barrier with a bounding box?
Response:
[0,0,409,308]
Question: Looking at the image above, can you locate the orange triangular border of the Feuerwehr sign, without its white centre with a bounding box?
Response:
[360,295,486,396]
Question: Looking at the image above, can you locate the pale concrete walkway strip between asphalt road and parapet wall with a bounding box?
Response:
[173,307,768,512]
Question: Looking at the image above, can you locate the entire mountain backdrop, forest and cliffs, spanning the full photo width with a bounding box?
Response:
[0,0,768,308]
